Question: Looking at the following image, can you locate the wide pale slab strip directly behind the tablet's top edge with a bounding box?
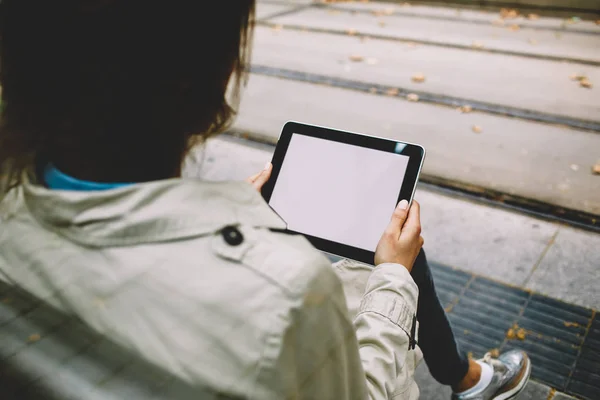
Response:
[235,75,600,214]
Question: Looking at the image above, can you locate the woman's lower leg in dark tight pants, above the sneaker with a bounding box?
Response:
[411,250,469,385]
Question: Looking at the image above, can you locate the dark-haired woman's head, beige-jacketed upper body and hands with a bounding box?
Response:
[0,0,528,399]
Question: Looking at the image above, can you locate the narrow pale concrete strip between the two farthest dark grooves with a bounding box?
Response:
[270,8,600,62]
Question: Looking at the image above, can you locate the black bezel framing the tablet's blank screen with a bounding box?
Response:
[261,122,425,264]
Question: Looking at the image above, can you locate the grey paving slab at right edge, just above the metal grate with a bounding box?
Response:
[527,227,600,310]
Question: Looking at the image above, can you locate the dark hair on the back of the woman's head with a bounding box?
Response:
[0,0,255,189]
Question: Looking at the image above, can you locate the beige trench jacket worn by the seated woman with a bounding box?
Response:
[0,179,421,400]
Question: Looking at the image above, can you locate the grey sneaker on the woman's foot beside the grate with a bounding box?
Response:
[452,350,531,400]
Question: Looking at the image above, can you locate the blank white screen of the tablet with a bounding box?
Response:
[269,134,409,251]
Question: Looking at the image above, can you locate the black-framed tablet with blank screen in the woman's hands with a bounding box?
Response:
[262,122,425,264]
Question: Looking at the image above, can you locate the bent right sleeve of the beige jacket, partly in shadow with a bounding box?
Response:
[280,256,417,400]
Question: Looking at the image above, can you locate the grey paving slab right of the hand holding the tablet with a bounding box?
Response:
[415,190,558,285]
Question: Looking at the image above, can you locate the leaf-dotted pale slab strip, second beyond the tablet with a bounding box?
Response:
[253,27,600,121]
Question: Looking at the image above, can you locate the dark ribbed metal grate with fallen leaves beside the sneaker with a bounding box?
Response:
[431,264,600,400]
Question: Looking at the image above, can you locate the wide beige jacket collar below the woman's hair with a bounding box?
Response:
[23,177,286,247]
